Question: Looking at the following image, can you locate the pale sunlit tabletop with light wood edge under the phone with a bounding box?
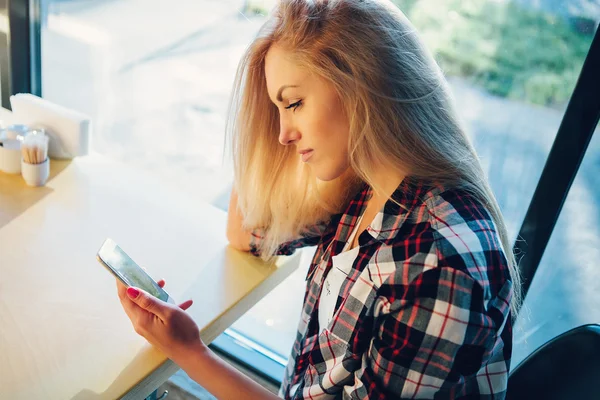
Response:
[0,154,299,400]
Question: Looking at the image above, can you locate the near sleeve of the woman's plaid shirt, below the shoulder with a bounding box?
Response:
[344,267,508,399]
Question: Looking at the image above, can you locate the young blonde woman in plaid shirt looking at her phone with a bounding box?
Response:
[119,0,519,400]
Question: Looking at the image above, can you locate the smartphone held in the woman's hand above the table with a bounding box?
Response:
[97,238,175,304]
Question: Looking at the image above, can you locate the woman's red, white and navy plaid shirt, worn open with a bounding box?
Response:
[251,178,512,399]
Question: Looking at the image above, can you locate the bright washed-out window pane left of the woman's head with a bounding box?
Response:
[42,0,262,202]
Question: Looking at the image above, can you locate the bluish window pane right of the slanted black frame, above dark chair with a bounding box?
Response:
[512,110,600,367]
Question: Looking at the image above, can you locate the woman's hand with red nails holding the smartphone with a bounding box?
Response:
[117,280,204,363]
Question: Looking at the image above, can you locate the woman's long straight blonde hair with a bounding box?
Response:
[228,0,520,315]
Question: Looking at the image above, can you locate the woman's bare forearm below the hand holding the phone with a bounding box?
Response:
[173,343,279,400]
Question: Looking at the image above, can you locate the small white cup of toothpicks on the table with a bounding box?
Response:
[21,130,50,186]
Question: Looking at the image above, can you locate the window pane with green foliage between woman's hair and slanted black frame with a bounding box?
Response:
[395,0,600,239]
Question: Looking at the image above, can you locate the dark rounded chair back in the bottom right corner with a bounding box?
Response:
[506,325,600,400]
